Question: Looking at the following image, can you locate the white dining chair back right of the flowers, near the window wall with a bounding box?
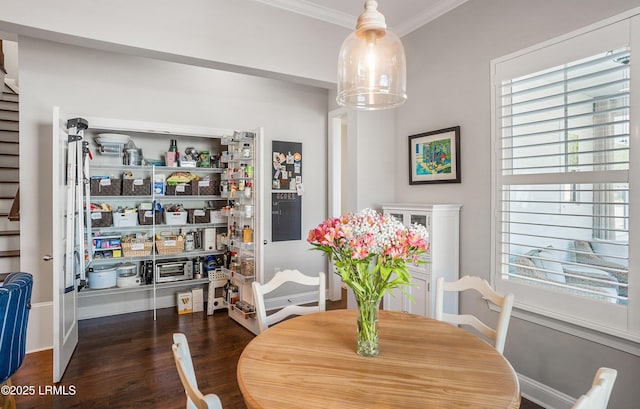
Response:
[435,276,514,354]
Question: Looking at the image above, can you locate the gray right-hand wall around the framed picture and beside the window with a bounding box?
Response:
[395,0,640,409]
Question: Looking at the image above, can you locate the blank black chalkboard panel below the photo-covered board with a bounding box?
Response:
[271,192,302,241]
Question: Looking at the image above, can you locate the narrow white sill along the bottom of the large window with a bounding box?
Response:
[489,303,640,356]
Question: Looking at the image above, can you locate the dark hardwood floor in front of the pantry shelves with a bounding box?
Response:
[12,296,541,409]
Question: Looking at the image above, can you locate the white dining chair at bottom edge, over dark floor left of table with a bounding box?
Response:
[171,333,222,409]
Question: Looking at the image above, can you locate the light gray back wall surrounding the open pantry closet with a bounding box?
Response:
[19,37,327,350]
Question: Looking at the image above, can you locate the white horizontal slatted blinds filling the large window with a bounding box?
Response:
[500,47,630,303]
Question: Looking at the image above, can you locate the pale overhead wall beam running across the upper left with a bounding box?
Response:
[0,0,350,85]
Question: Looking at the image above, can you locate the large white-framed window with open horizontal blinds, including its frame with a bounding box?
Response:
[492,15,640,340]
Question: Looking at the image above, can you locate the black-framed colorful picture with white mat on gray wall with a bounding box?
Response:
[409,126,460,185]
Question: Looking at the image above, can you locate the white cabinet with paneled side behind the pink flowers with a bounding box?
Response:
[382,203,461,318]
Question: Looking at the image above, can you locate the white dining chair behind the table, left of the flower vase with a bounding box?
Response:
[252,270,326,332]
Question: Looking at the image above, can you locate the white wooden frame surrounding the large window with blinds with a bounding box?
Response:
[490,8,640,346]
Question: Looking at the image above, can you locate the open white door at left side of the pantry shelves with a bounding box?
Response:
[51,107,82,382]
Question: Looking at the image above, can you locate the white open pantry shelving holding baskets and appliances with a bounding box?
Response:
[77,118,262,319]
